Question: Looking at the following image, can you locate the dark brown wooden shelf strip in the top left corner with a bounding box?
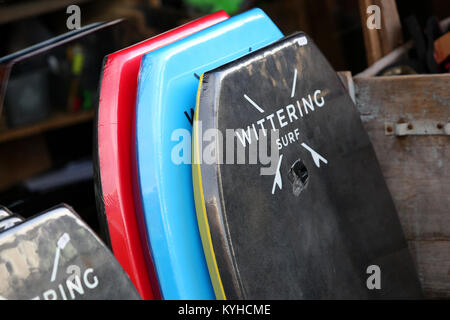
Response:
[0,0,92,24]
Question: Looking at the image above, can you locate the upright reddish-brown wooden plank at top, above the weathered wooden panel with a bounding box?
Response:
[358,0,403,66]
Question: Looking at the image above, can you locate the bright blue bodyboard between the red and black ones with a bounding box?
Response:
[136,9,283,299]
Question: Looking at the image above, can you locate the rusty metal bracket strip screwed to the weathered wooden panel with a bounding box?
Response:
[384,120,450,136]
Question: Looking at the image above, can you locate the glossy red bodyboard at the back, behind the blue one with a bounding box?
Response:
[95,11,228,300]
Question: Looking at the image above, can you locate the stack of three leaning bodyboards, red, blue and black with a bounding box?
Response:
[94,9,422,299]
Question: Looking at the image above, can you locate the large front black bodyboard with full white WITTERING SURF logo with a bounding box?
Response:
[193,33,421,299]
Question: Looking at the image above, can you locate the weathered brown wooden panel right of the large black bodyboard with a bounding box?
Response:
[352,75,450,298]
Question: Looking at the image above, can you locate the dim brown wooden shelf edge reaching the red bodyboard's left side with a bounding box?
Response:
[0,110,94,143]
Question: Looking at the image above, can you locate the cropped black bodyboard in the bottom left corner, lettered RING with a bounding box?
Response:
[0,206,140,300]
